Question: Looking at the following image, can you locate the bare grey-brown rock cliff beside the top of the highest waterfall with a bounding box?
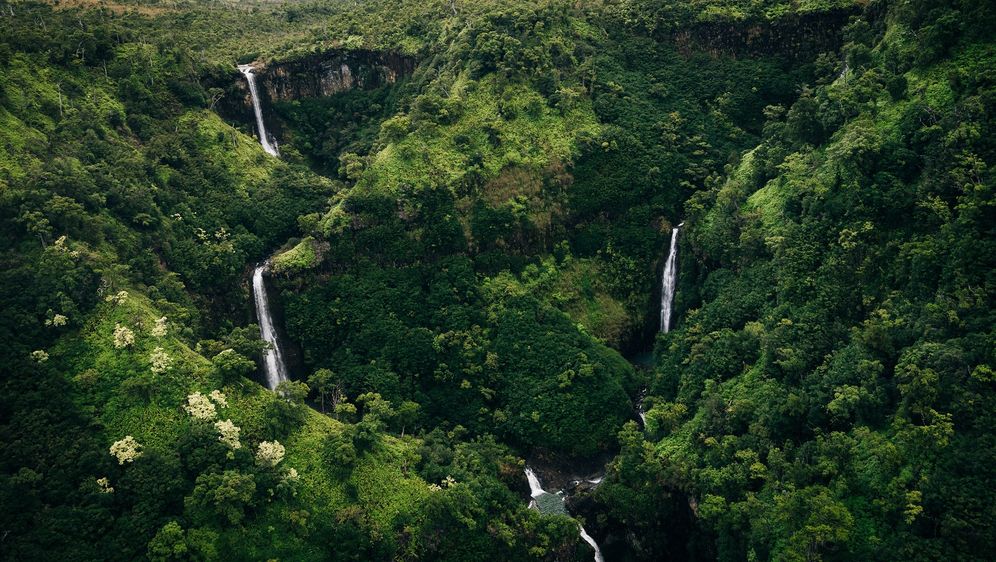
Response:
[257,51,415,102]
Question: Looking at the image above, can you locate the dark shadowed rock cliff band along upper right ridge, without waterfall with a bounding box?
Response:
[667,9,858,60]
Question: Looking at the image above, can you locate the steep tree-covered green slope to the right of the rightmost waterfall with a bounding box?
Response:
[599,5,996,560]
